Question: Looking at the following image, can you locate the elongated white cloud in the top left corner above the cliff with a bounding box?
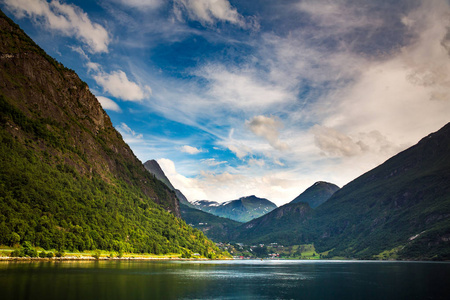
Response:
[4,0,110,53]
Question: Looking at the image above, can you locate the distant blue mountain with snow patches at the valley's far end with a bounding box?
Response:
[192,196,277,222]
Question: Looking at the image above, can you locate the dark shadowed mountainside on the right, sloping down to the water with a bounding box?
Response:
[234,124,450,259]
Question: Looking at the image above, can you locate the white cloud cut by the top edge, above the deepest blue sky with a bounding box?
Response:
[174,0,247,27]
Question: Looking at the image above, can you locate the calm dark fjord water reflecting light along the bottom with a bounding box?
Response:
[0,261,450,300]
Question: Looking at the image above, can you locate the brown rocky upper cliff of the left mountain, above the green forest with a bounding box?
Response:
[0,12,180,216]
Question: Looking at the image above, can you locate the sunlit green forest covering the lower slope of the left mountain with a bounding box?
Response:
[0,118,225,256]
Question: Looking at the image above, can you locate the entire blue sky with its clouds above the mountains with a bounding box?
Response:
[0,0,450,205]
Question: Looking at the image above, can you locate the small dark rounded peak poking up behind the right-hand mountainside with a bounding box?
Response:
[291,181,339,208]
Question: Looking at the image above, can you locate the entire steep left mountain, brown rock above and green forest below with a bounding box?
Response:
[0,11,223,255]
